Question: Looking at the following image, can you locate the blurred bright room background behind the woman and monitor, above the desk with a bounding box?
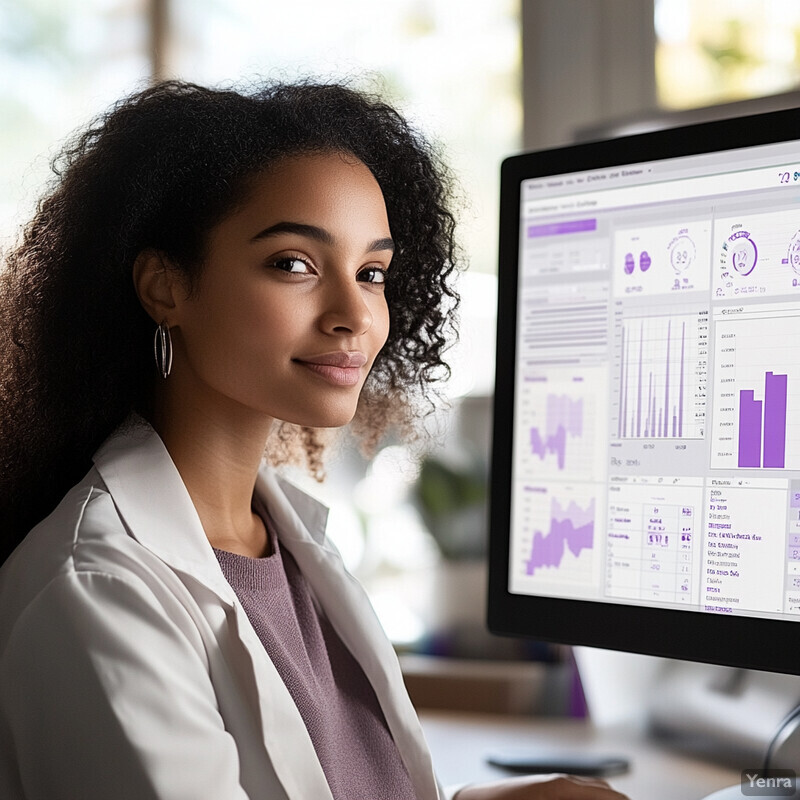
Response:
[0,0,800,715]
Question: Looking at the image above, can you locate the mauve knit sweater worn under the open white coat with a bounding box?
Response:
[214,521,422,800]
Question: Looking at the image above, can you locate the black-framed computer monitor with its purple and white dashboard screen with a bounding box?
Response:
[489,106,800,672]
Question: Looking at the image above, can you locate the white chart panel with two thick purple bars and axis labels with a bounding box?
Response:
[711,304,800,469]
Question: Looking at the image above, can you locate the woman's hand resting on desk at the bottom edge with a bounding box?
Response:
[454,775,627,800]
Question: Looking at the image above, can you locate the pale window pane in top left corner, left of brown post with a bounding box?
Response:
[0,0,150,246]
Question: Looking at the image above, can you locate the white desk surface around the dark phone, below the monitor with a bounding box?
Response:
[420,711,739,800]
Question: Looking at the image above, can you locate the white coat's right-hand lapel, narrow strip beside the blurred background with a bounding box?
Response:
[256,468,439,800]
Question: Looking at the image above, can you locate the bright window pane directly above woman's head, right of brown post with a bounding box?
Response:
[166,0,522,272]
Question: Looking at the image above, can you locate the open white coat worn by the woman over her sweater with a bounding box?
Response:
[0,418,450,800]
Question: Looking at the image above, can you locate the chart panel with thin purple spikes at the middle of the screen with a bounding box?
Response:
[612,313,708,439]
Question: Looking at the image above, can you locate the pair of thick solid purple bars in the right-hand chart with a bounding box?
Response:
[738,372,788,469]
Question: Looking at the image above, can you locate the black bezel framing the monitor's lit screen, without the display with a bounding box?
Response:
[487,109,800,674]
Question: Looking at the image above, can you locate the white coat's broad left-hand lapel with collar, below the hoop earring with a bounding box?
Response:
[94,417,332,800]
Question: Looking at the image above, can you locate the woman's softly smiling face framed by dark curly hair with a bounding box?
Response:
[167,148,393,427]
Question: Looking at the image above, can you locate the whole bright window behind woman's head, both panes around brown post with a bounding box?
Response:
[0,0,522,272]
